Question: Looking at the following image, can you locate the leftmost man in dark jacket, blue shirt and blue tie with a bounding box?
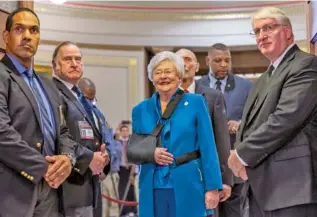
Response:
[0,8,81,217]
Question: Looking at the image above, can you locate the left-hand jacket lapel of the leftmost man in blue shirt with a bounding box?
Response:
[1,55,42,129]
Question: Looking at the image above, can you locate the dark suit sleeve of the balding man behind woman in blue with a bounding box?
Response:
[210,93,233,186]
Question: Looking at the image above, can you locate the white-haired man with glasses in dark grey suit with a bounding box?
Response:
[228,7,317,217]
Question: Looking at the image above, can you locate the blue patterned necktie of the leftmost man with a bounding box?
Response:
[24,70,56,156]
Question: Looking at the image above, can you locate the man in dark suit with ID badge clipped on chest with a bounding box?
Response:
[52,41,110,217]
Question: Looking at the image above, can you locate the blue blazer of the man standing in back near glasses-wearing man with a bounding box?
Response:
[197,74,252,149]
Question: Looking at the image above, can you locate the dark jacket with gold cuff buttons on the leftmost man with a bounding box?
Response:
[0,56,77,217]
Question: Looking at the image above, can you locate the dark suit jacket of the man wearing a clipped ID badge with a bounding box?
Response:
[53,78,110,208]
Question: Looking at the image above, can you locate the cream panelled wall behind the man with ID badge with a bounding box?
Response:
[35,45,145,128]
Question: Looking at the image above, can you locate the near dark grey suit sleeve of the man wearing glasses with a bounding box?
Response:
[236,57,317,167]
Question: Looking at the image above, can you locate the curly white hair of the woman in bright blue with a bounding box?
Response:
[147,51,185,82]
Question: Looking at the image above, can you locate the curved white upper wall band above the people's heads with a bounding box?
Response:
[35,3,306,47]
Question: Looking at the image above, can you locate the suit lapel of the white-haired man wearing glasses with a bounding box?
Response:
[243,45,299,125]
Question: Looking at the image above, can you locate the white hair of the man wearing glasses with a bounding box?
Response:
[251,7,292,28]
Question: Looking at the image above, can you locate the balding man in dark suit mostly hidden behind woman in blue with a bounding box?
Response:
[176,49,233,210]
